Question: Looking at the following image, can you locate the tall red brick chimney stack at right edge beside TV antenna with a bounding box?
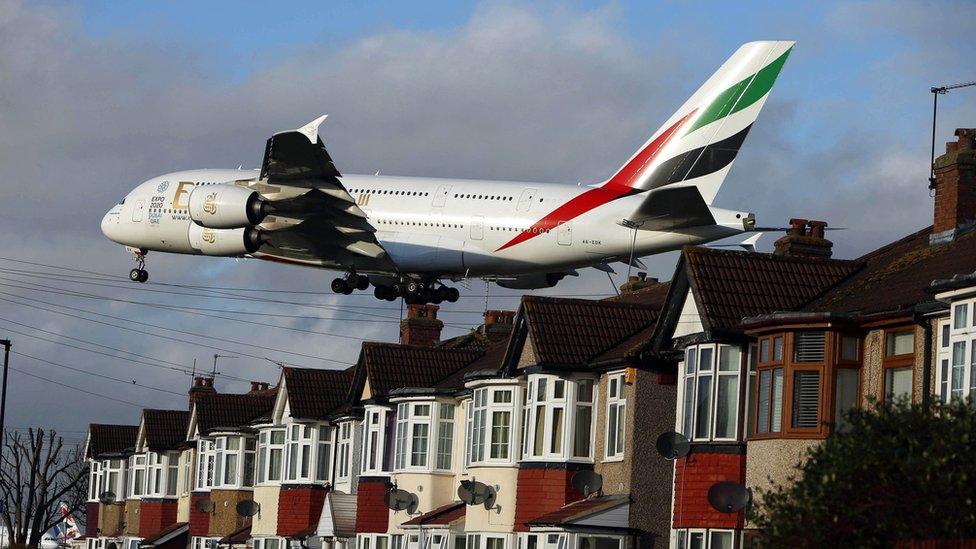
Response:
[929,128,976,244]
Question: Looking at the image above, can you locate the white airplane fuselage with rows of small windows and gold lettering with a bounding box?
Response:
[102,169,743,278]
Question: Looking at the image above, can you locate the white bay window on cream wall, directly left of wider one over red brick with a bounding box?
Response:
[465,385,518,465]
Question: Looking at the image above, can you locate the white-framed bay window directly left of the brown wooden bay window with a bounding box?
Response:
[679,344,742,441]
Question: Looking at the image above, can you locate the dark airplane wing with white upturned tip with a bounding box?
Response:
[255,115,395,272]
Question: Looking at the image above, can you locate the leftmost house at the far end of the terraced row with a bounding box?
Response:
[84,423,139,549]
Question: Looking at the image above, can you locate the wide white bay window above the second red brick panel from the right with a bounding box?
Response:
[528,374,594,461]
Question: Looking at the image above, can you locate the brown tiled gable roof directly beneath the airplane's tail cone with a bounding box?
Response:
[682,246,862,330]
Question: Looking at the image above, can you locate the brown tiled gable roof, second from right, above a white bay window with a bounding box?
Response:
[521,296,660,366]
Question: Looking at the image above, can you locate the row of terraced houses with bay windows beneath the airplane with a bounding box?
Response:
[85,129,976,549]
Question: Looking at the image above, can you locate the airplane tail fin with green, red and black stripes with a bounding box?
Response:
[603,41,795,204]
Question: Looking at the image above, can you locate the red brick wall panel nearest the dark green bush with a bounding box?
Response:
[673,447,746,528]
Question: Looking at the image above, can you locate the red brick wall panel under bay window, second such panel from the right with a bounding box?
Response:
[515,463,583,532]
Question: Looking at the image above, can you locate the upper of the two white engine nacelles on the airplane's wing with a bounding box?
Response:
[187,185,269,229]
